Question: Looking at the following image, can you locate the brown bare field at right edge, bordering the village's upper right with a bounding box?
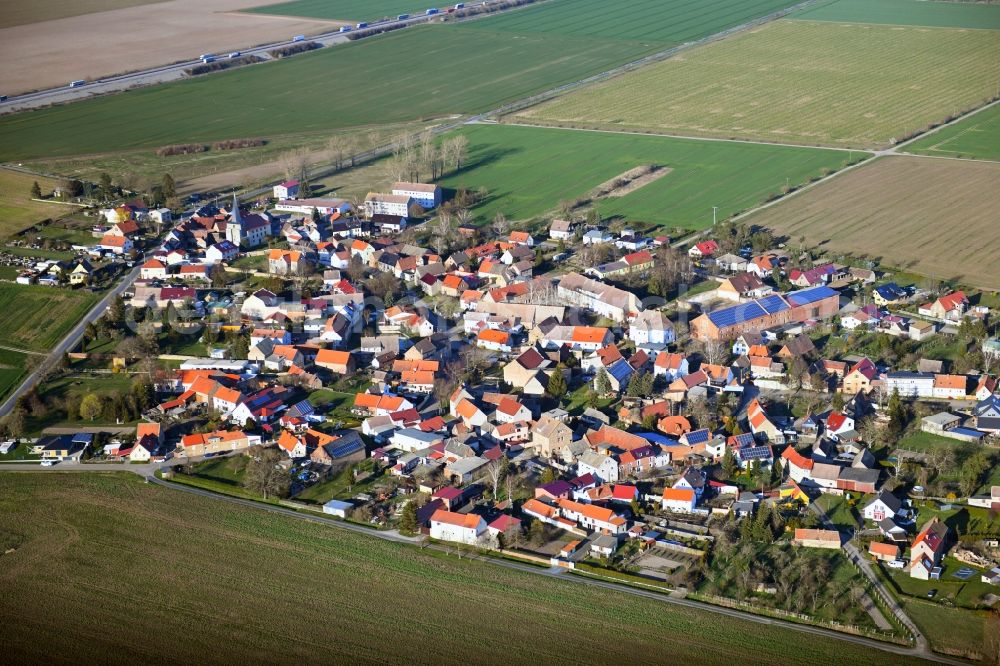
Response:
[747,156,1000,290]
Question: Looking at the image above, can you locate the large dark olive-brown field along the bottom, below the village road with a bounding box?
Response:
[0,473,928,666]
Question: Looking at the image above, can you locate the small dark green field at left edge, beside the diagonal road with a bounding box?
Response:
[0,283,100,352]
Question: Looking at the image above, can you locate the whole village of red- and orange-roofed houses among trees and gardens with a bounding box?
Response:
[11,174,1000,632]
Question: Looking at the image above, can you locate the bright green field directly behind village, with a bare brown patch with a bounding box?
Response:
[434,125,848,228]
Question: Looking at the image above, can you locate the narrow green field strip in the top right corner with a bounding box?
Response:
[793,0,1000,30]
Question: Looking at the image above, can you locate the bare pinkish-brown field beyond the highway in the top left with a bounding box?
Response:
[0,0,341,95]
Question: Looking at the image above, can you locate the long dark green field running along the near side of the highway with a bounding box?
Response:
[0,0,804,161]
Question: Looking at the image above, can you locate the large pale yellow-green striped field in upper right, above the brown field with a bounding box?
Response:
[519,20,1000,148]
